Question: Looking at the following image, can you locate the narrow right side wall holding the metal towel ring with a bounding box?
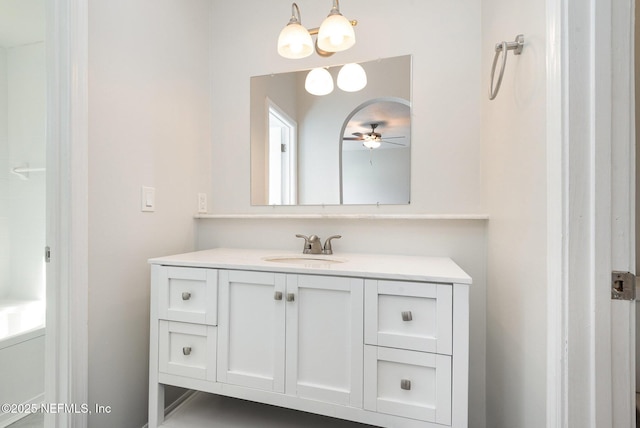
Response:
[482,0,547,428]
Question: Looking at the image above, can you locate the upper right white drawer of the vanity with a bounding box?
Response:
[365,280,453,355]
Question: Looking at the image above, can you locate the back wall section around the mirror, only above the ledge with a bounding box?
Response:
[210,0,482,213]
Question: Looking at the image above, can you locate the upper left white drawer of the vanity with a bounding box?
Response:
[158,266,218,325]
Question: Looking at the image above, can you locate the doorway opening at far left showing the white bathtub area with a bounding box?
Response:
[0,0,47,427]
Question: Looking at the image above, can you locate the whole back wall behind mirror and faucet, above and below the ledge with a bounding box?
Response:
[202,0,487,428]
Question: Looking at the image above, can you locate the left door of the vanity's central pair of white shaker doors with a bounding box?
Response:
[217,270,285,392]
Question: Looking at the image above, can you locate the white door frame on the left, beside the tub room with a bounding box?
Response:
[45,0,88,428]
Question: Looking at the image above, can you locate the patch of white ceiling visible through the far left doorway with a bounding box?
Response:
[0,0,45,48]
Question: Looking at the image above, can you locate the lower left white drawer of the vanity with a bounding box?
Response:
[158,320,217,381]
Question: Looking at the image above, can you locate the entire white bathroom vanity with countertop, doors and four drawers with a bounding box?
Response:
[149,249,471,428]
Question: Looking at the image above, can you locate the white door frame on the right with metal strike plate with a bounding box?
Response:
[546,0,635,428]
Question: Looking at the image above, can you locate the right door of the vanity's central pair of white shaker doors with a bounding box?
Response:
[286,275,364,407]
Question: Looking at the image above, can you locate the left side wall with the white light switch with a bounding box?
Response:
[88,0,211,428]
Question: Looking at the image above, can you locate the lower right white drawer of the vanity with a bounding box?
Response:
[364,346,451,425]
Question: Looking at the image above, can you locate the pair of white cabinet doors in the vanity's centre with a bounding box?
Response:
[218,270,363,407]
